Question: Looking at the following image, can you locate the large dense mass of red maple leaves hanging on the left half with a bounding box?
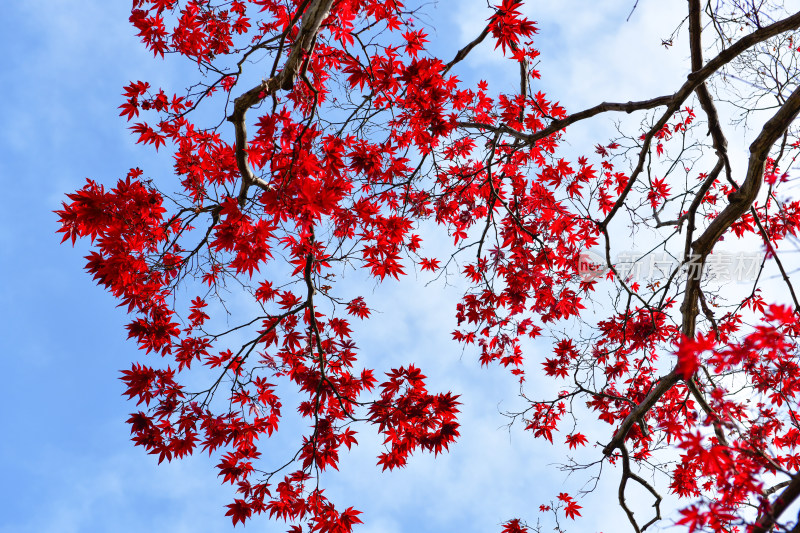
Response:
[58,0,530,531]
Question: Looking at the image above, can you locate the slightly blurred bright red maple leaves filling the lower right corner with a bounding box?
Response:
[671,305,800,532]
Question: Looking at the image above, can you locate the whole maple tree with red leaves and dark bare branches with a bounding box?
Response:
[58,0,800,533]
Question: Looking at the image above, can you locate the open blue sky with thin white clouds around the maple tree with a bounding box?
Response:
[0,0,683,533]
